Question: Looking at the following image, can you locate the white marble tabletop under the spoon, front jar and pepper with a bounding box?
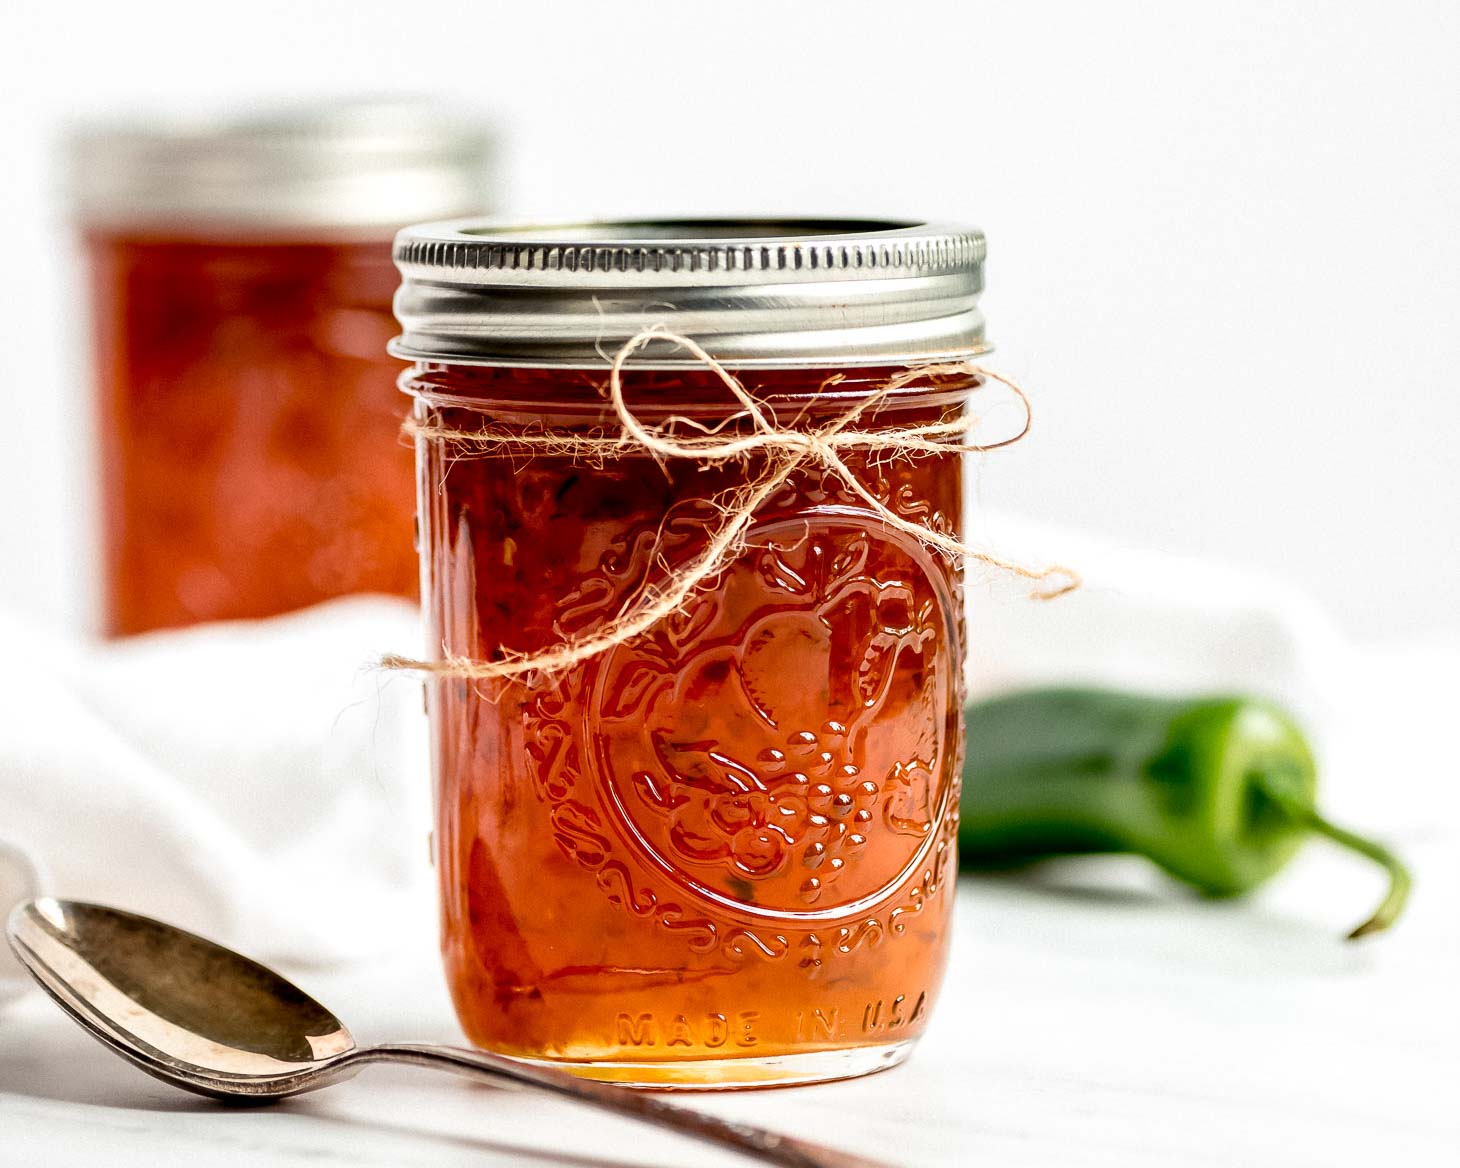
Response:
[0,831,1460,1168]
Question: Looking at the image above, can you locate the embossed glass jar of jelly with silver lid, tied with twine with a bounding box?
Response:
[393,220,984,1086]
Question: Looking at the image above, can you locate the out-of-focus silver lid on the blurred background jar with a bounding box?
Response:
[67,101,495,232]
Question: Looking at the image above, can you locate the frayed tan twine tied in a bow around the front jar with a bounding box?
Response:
[381,324,1080,680]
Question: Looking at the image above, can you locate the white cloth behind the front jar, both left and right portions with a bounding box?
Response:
[0,515,1460,999]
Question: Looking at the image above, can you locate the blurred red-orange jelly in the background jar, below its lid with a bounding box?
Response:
[86,229,418,634]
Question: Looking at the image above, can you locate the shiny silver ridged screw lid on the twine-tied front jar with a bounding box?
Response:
[391,219,988,368]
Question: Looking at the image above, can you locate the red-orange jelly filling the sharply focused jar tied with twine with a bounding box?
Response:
[406,364,972,1085]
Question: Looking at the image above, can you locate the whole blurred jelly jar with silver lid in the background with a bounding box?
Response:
[72,102,492,635]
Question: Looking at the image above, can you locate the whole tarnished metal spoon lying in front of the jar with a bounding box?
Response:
[7,898,886,1168]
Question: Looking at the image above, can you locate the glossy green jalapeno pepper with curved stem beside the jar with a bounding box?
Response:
[958,689,1410,937]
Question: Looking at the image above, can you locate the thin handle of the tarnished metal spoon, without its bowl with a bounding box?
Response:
[356,1042,891,1168]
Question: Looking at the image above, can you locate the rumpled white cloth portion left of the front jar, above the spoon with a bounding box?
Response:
[0,597,429,1000]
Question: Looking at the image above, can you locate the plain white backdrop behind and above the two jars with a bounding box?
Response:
[0,0,1460,638]
